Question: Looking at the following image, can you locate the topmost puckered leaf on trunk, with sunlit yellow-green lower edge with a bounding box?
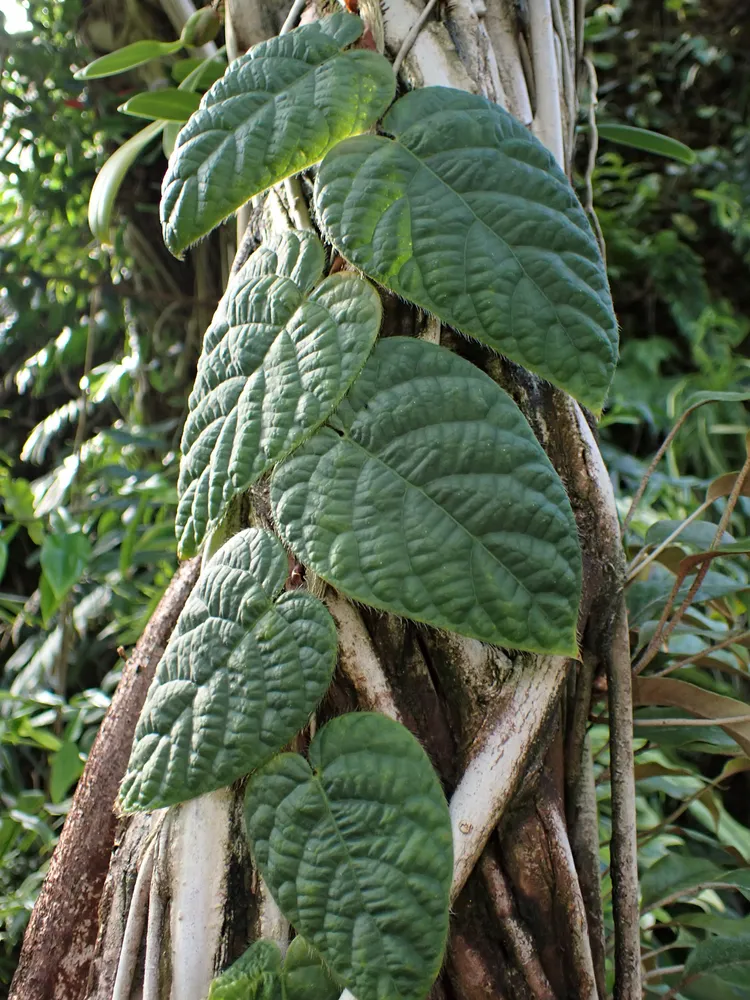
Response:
[161,12,396,254]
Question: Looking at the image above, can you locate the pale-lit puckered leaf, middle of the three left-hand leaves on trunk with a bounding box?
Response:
[176,231,381,555]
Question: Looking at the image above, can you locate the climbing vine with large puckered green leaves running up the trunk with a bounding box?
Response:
[85,12,617,1000]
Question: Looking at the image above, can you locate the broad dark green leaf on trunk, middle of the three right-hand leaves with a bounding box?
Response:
[271,337,581,654]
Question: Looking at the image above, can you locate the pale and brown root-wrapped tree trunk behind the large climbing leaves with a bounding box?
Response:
[12,0,640,1000]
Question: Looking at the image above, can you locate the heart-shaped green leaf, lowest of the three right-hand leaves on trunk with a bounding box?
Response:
[245,713,453,1000]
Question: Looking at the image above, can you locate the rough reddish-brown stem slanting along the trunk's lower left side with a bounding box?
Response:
[10,559,200,1000]
